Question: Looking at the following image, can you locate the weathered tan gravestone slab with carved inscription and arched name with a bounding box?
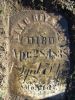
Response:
[9,11,69,99]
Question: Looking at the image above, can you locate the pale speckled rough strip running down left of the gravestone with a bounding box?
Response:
[0,0,9,100]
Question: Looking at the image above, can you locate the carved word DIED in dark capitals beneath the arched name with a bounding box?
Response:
[20,35,55,45]
